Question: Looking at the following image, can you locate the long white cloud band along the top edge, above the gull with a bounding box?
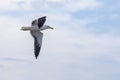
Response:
[0,0,102,12]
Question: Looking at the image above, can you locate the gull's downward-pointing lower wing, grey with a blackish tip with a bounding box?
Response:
[31,31,43,59]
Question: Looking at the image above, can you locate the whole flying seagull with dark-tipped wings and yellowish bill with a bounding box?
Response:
[21,16,53,59]
